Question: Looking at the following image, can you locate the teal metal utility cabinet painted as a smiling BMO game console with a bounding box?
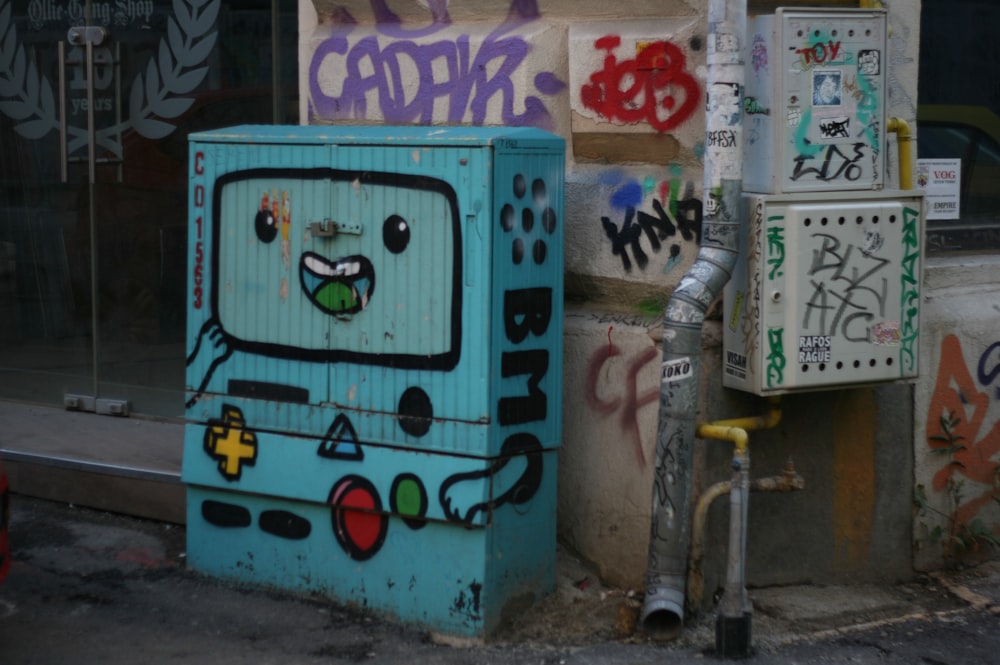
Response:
[183,126,565,636]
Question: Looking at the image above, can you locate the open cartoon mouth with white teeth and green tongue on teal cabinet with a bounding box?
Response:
[299,252,375,316]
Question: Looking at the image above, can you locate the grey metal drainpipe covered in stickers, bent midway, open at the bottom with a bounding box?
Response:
[640,0,747,639]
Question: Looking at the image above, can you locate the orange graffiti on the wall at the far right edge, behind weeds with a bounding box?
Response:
[926,335,1000,527]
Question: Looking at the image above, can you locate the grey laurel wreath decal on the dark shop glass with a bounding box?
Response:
[0,0,221,157]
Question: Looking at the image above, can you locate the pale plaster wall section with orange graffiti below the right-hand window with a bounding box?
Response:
[913,256,1000,570]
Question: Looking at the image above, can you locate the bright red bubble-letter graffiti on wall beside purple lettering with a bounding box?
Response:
[580,35,701,132]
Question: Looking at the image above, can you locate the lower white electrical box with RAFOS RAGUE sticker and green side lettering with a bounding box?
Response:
[723,190,924,395]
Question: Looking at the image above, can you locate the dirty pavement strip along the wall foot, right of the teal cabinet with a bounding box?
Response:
[490,536,1000,652]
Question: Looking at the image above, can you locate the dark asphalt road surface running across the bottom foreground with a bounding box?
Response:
[0,496,1000,665]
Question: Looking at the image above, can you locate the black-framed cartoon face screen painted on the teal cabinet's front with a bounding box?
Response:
[213,169,461,366]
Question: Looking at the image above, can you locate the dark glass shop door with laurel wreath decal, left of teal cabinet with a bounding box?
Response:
[0,0,298,416]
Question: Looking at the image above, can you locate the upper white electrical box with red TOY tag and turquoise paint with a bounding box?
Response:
[743,8,887,194]
